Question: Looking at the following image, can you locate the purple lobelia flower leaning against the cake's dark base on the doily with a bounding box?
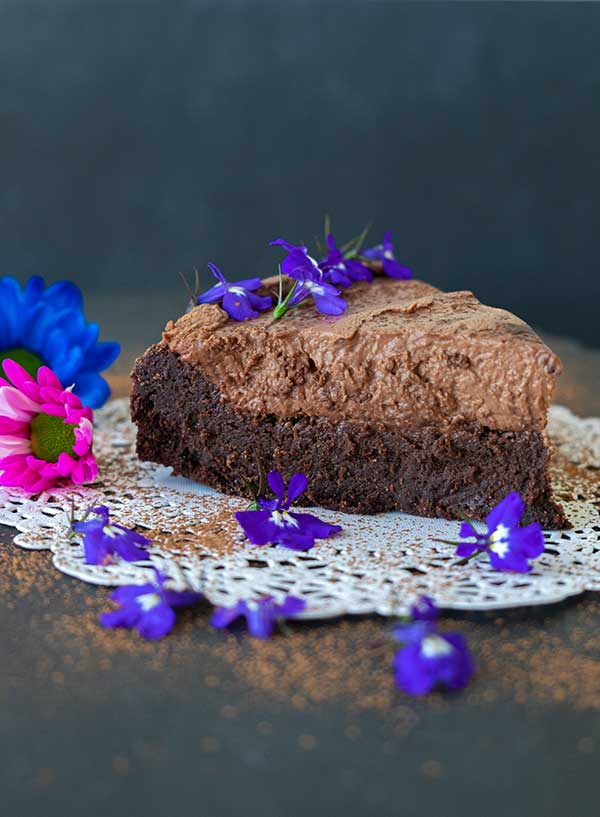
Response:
[235,471,341,550]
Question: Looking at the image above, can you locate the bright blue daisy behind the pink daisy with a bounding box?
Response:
[0,275,121,408]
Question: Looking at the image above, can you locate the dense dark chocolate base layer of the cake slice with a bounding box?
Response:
[131,341,567,529]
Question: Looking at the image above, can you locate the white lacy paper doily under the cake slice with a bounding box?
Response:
[0,400,600,619]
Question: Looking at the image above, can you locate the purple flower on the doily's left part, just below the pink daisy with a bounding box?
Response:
[71,505,150,565]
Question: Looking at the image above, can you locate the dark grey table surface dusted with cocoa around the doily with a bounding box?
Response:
[0,326,600,817]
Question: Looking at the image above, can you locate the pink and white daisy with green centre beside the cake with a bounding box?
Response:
[0,360,98,494]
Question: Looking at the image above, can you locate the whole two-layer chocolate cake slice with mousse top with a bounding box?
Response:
[131,277,566,528]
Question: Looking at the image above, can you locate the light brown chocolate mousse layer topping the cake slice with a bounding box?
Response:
[163,278,561,431]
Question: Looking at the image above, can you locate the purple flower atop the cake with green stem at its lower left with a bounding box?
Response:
[270,238,347,318]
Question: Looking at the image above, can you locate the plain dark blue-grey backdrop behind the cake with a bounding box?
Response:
[0,0,600,344]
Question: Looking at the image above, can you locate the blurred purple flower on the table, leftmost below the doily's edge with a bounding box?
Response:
[100,570,202,638]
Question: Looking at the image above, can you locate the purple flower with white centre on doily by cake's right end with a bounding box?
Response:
[456,491,544,573]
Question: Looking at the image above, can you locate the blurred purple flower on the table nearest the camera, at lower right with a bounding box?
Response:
[394,596,475,695]
